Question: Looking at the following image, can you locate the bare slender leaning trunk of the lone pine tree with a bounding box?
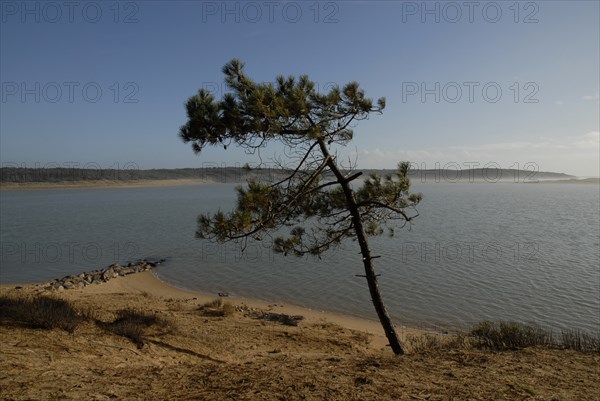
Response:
[319,140,404,355]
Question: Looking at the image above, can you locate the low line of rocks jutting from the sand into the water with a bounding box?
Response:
[43,259,164,291]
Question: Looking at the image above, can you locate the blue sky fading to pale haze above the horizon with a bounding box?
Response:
[0,1,600,176]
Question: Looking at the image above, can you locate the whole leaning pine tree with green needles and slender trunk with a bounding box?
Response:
[180,59,421,354]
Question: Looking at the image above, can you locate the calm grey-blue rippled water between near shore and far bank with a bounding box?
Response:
[0,183,600,332]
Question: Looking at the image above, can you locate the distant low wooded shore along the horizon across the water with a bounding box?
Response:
[0,167,575,183]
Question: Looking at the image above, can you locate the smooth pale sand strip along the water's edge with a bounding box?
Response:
[0,270,404,349]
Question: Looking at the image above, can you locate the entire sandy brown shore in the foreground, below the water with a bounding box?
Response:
[0,272,600,401]
